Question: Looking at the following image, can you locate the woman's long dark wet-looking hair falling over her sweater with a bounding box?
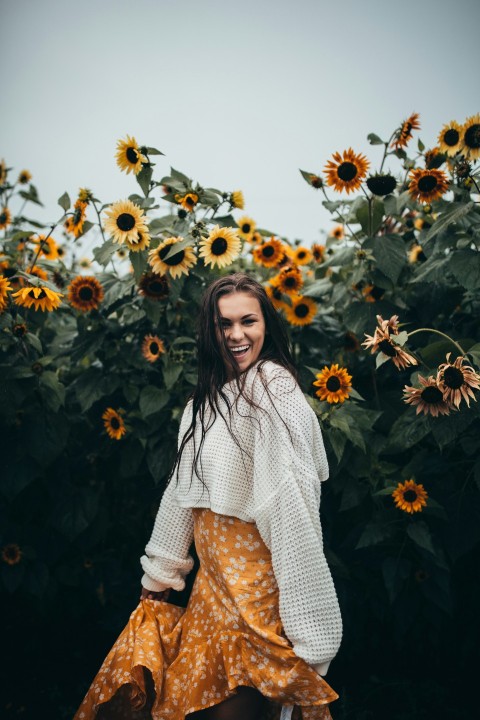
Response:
[168,273,297,483]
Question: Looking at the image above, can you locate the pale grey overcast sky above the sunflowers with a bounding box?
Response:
[0,0,480,245]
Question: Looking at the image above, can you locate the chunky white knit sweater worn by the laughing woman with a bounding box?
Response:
[141,362,342,674]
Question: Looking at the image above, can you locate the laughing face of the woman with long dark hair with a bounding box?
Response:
[218,292,265,372]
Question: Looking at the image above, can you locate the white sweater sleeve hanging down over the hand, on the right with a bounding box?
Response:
[254,371,342,674]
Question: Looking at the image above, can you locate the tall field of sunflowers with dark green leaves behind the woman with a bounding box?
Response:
[0,114,480,720]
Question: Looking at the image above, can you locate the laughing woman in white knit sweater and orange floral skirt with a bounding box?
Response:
[76,273,342,720]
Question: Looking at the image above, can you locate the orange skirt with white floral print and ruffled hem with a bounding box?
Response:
[74,508,338,720]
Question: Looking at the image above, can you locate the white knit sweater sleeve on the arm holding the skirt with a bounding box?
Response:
[140,404,193,592]
